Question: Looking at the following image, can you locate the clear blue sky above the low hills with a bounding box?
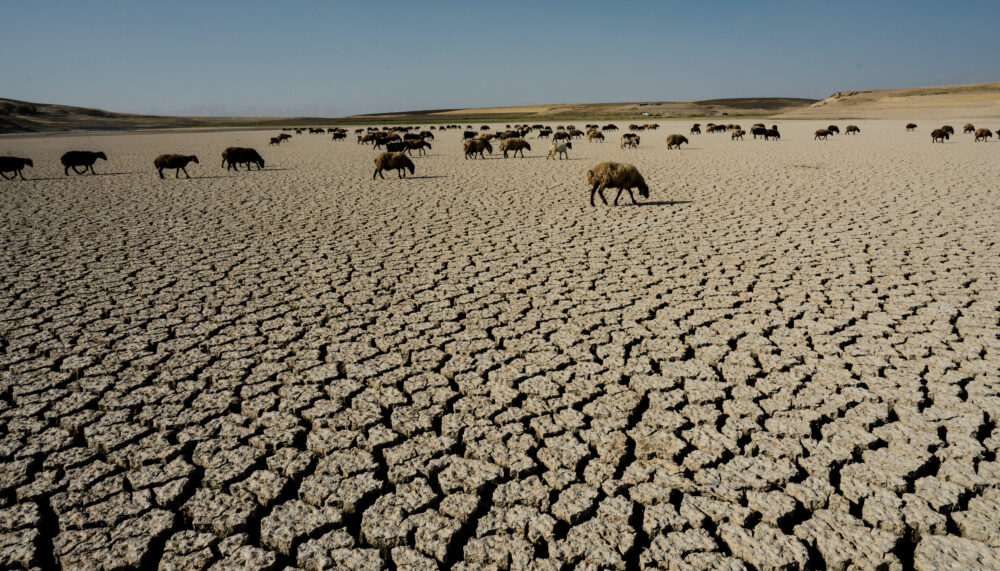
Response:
[0,0,1000,116]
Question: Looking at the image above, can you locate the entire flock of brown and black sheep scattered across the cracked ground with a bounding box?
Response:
[0,123,1000,206]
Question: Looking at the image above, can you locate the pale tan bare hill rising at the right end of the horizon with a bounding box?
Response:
[782,83,1000,119]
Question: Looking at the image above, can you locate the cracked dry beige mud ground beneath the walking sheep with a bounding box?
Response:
[0,121,1000,570]
